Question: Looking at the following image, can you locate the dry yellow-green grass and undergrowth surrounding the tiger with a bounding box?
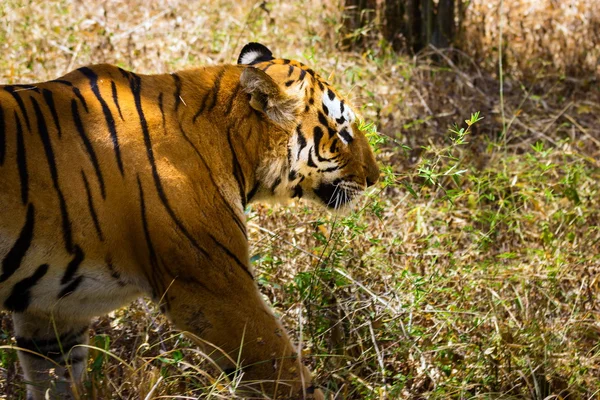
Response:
[0,0,600,399]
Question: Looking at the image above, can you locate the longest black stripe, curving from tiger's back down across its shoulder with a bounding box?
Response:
[130,72,210,258]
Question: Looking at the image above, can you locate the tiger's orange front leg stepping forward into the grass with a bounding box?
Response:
[162,282,324,400]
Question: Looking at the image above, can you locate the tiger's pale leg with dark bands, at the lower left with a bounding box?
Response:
[13,313,89,400]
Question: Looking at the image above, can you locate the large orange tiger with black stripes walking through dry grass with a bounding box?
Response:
[0,42,379,400]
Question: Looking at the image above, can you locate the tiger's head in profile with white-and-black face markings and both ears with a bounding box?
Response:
[238,43,379,209]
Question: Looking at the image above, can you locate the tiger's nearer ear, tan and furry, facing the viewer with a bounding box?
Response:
[240,67,298,129]
